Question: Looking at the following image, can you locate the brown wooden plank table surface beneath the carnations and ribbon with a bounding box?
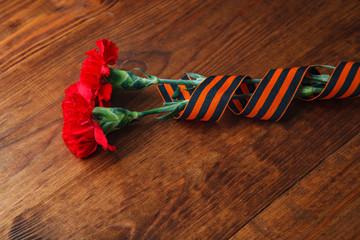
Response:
[0,0,360,240]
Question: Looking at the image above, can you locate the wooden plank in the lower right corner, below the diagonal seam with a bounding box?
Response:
[230,135,360,240]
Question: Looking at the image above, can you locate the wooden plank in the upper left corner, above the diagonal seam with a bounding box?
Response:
[0,0,116,71]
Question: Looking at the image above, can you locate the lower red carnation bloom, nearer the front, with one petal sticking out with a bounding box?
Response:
[62,82,115,158]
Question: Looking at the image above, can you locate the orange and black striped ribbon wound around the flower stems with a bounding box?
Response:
[157,62,360,121]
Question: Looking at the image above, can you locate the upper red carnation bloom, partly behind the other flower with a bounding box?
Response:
[80,39,118,107]
